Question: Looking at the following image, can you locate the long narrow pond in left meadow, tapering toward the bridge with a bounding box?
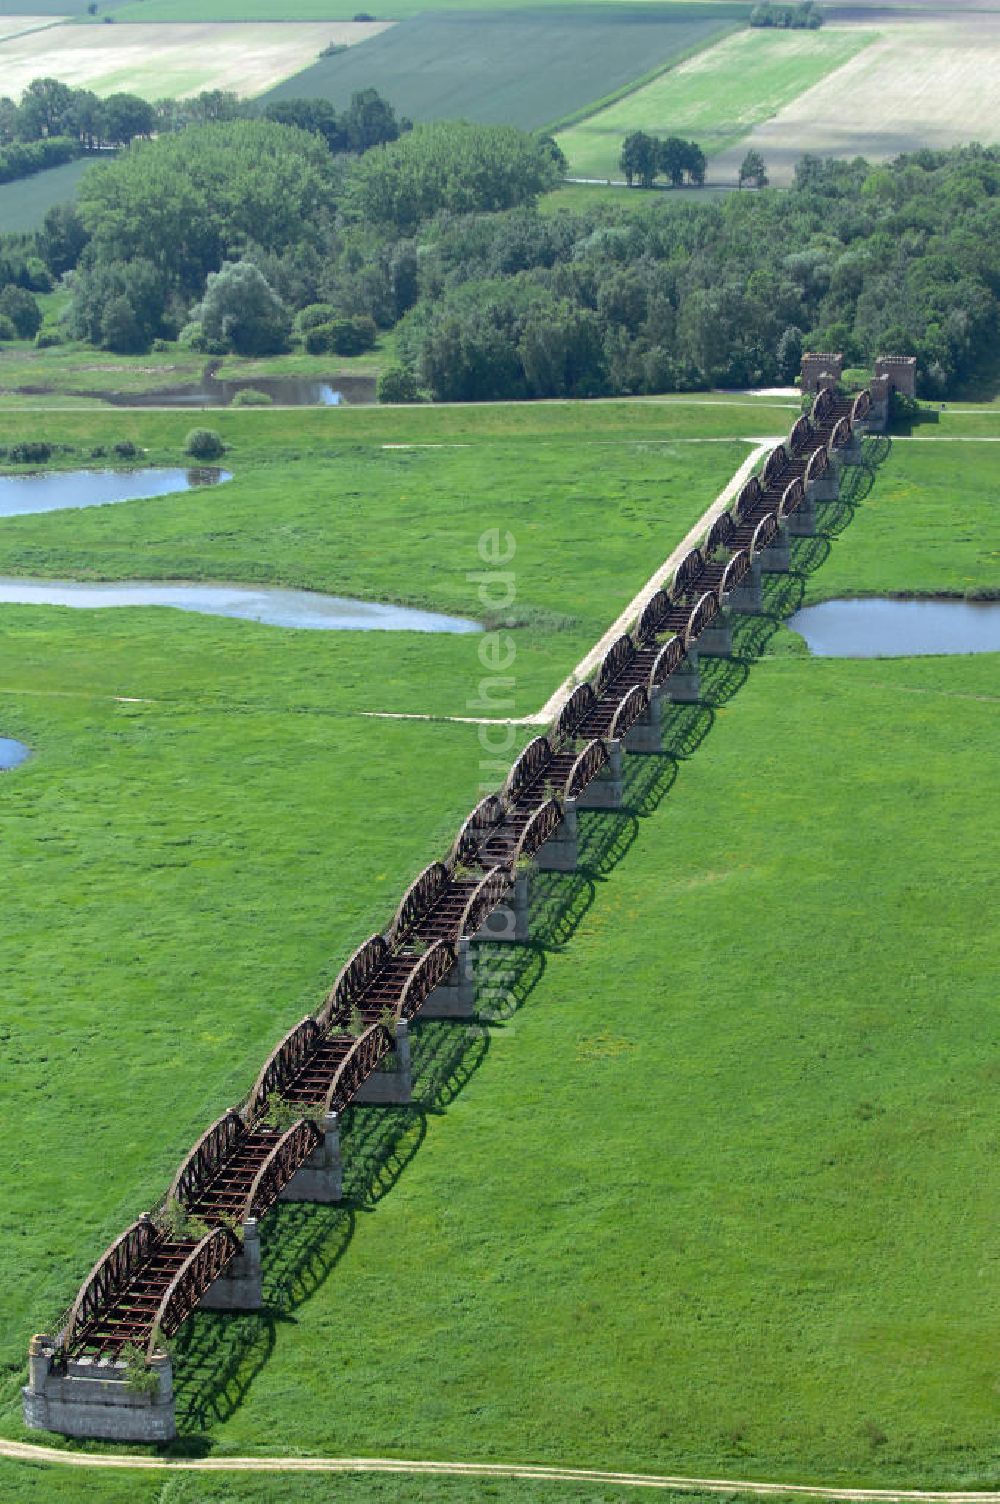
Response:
[0,579,483,632]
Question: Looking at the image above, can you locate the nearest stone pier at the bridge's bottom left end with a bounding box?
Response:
[21,1334,177,1444]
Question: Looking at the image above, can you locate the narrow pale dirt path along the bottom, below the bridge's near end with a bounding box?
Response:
[0,1441,1000,1504]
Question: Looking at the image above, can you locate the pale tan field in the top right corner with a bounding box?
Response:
[713,12,1000,183]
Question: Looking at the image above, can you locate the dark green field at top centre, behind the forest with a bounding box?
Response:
[266,5,731,129]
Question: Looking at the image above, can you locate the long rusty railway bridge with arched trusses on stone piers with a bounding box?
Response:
[24,356,905,1442]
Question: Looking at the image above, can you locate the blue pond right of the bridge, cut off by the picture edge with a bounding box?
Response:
[788,599,1000,657]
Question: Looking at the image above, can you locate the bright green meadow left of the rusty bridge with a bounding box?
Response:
[0,406,746,1419]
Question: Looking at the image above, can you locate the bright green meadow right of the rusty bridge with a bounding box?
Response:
[3,405,997,1496]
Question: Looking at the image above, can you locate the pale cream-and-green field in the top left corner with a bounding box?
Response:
[0,20,388,99]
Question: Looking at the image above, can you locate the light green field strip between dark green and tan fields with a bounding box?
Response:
[556,26,872,177]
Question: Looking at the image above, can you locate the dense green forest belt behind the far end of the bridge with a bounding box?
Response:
[0,109,1000,400]
